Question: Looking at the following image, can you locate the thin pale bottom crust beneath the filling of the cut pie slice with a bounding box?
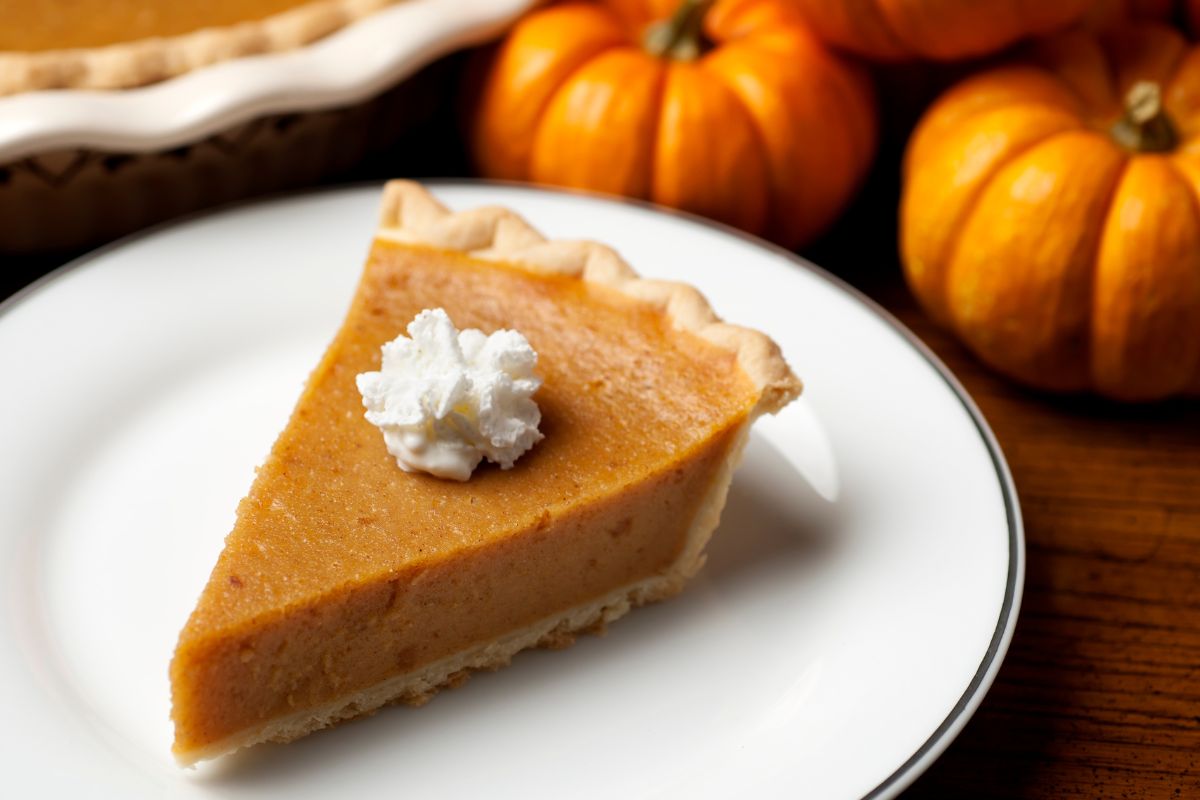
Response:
[175,415,756,766]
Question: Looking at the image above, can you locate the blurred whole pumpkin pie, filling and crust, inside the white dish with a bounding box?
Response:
[0,0,397,96]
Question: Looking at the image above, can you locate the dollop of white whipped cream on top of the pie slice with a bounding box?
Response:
[358,308,542,481]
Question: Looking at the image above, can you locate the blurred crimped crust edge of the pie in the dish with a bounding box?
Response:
[0,0,397,97]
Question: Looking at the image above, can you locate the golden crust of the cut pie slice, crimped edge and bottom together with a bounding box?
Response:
[173,181,800,764]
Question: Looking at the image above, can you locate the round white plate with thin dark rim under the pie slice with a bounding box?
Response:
[0,184,1024,798]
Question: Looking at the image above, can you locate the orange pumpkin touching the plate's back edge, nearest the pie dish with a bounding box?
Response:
[470,0,876,247]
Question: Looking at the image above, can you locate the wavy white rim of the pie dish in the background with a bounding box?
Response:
[0,0,535,163]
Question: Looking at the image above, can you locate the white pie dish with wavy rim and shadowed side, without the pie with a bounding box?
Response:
[0,0,534,253]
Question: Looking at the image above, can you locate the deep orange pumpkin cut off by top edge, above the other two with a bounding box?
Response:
[793,0,1092,61]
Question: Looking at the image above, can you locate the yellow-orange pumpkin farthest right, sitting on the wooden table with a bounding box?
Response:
[900,24,1200,401]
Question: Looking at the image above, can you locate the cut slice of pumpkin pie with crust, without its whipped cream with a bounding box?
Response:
[170,181,800,763]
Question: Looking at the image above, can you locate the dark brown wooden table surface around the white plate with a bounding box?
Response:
[0,130,1200,799]
